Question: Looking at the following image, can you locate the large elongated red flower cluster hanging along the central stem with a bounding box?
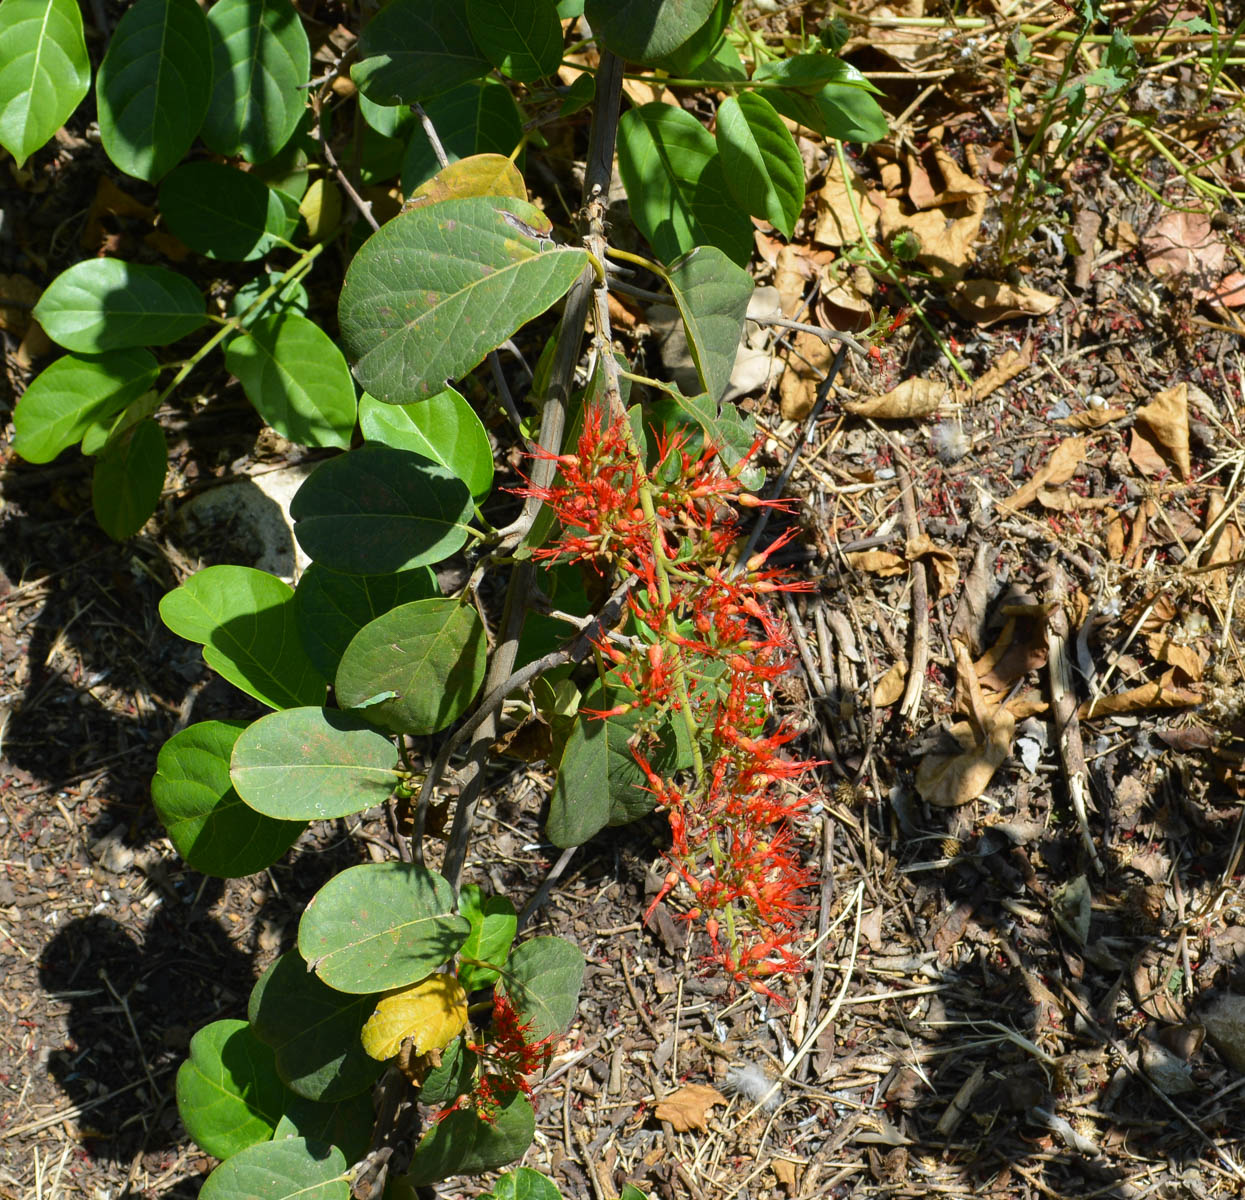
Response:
[525,407,818,992]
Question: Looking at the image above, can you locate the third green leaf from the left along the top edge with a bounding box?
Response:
[203,0,311,163]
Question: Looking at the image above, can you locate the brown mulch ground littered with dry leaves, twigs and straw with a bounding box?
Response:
[0,4,1245,1200]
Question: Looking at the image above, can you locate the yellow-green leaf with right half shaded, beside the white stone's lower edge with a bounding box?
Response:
[159,566,325,708]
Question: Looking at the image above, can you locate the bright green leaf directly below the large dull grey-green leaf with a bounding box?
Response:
[359,387,493,503]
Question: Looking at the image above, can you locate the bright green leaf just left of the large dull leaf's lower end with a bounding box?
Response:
[225,313,356,449]
